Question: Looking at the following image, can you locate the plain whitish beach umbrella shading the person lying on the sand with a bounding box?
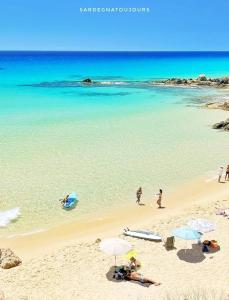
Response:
[99,238,132,265]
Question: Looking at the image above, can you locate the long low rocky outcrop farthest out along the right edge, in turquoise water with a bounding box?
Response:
[152,74,229,88]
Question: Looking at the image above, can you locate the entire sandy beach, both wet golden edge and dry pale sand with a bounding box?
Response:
[0,179,229,300]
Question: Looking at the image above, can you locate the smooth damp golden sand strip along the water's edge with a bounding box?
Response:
[0,178,229,259]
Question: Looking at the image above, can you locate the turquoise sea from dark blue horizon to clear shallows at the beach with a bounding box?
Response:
[0,52,229,235]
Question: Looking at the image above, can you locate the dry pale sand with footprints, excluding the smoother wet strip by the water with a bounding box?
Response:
[0,182,229,300]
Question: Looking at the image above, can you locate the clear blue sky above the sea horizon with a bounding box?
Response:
[0,0,229,51]
